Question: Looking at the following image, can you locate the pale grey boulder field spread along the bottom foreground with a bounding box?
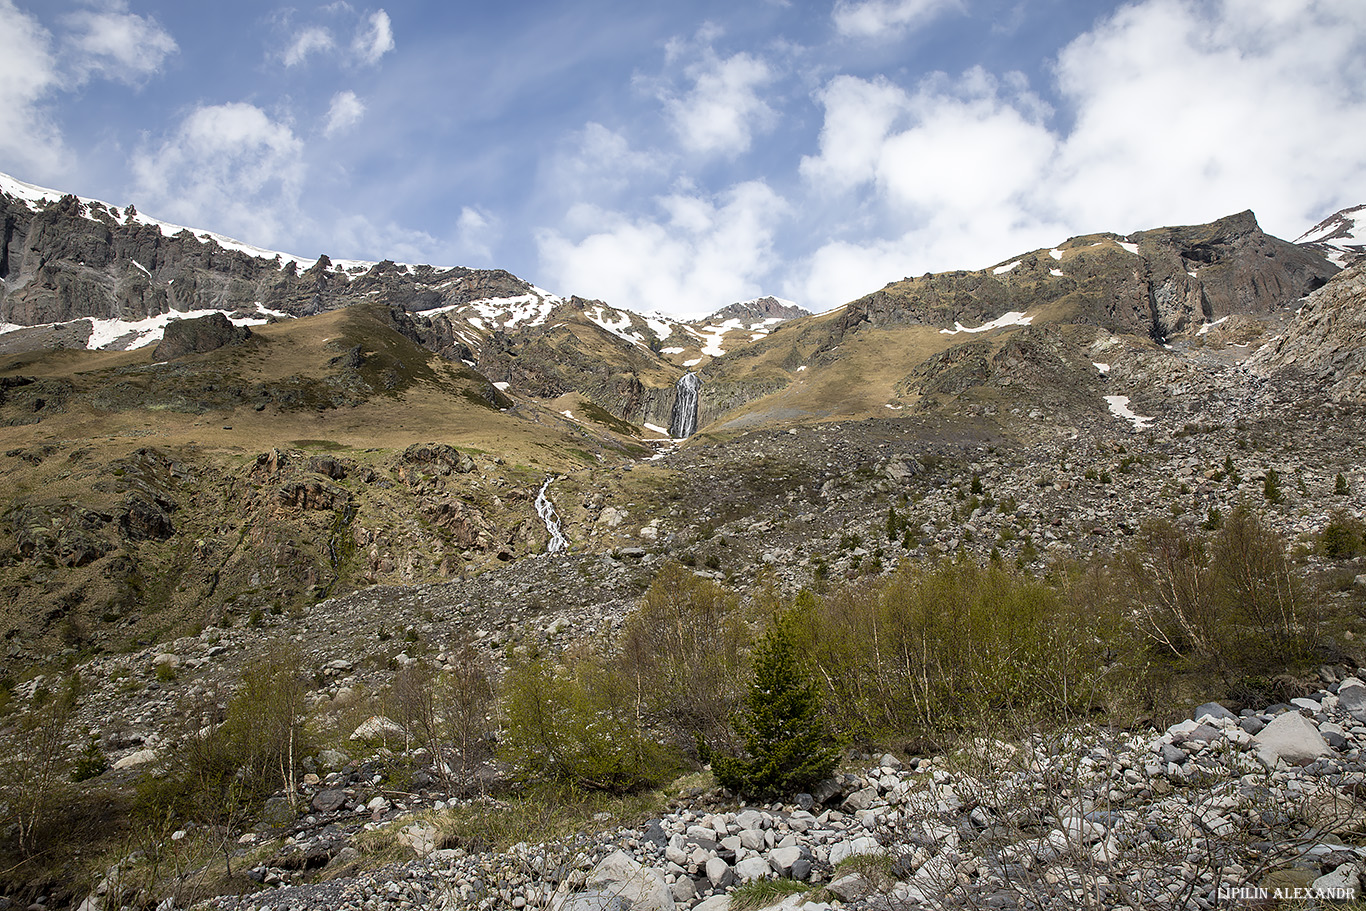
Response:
[168,668,1366,911]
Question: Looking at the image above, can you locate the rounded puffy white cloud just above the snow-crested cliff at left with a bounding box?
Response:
[131,102,306,247]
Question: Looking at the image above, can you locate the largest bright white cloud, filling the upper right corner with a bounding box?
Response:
[1056,0,1366,236]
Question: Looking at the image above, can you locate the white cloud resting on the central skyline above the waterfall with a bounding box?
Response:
[537,180,787,317]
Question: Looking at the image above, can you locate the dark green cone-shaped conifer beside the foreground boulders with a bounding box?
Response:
[709,616,840,799]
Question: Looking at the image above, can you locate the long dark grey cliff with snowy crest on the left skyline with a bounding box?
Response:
[0,187,530,334]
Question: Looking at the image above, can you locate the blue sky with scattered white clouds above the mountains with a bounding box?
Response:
[0,0,1366,318]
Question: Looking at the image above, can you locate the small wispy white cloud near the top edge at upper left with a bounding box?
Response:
[61,0,179,86]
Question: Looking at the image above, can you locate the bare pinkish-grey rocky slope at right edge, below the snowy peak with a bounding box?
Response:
[1249,262,1366,403]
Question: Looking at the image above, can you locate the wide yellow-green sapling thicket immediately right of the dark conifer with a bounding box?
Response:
[795,560,1121,740]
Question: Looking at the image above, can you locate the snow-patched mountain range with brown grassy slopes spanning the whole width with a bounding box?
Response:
[0,167,1366,658]
